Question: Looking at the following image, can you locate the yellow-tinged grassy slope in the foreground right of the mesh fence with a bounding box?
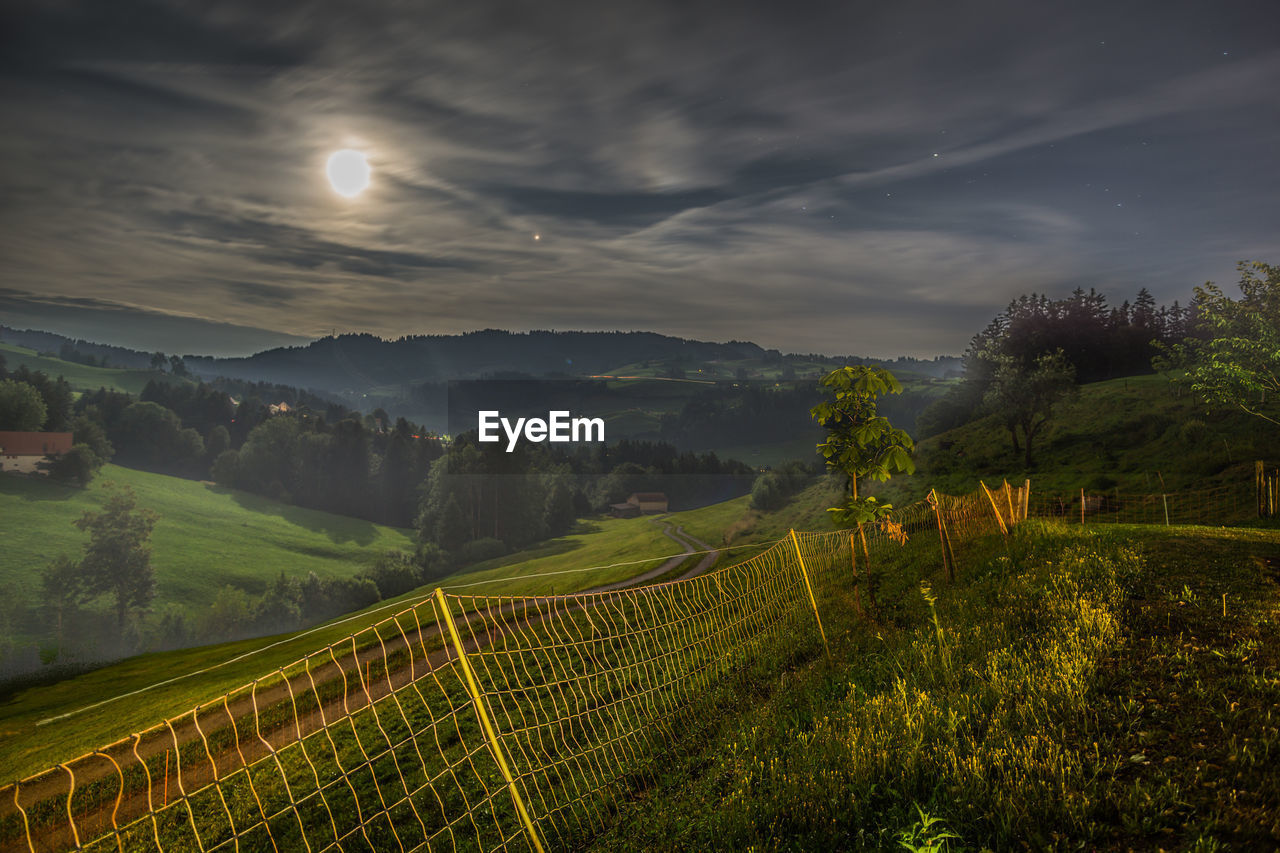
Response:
[595,521,1280,850]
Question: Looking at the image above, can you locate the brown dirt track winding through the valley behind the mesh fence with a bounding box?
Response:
[0,523,718,850]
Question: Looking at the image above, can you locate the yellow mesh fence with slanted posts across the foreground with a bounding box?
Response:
[0,484,1029,853]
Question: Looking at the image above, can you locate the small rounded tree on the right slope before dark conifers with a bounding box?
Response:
[984,350,1076,469]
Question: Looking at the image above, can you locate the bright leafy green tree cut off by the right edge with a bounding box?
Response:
[1153,261,1280,427]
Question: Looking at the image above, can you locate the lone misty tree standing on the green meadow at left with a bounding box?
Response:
[76,484,159,629]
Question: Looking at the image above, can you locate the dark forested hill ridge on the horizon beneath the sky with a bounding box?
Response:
[187,329,767,391]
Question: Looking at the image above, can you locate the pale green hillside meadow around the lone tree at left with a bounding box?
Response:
[0,465,413,625]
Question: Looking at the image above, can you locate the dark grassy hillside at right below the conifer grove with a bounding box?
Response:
[879,375,1280,500]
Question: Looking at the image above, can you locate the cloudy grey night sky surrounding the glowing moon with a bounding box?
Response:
[0,0,1280,357]
